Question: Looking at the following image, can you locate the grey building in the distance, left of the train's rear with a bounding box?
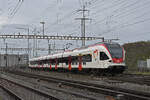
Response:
[0,54,28,67]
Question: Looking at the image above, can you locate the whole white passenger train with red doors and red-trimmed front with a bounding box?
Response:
[29,42,127,75]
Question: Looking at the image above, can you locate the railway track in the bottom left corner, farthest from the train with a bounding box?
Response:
[0,76,61,100]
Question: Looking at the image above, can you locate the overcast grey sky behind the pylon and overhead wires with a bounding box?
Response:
[0,0,150,56]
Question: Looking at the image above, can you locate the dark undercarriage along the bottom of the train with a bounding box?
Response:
[31,66,127,76]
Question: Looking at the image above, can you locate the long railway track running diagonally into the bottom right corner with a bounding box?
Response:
[4,71,150,100]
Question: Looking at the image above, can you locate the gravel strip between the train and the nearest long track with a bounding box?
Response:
[23,70,150,93]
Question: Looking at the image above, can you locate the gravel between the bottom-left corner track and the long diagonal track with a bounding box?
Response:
[2,71,108,100]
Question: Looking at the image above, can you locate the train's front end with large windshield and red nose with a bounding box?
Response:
[105,43,127,73]
